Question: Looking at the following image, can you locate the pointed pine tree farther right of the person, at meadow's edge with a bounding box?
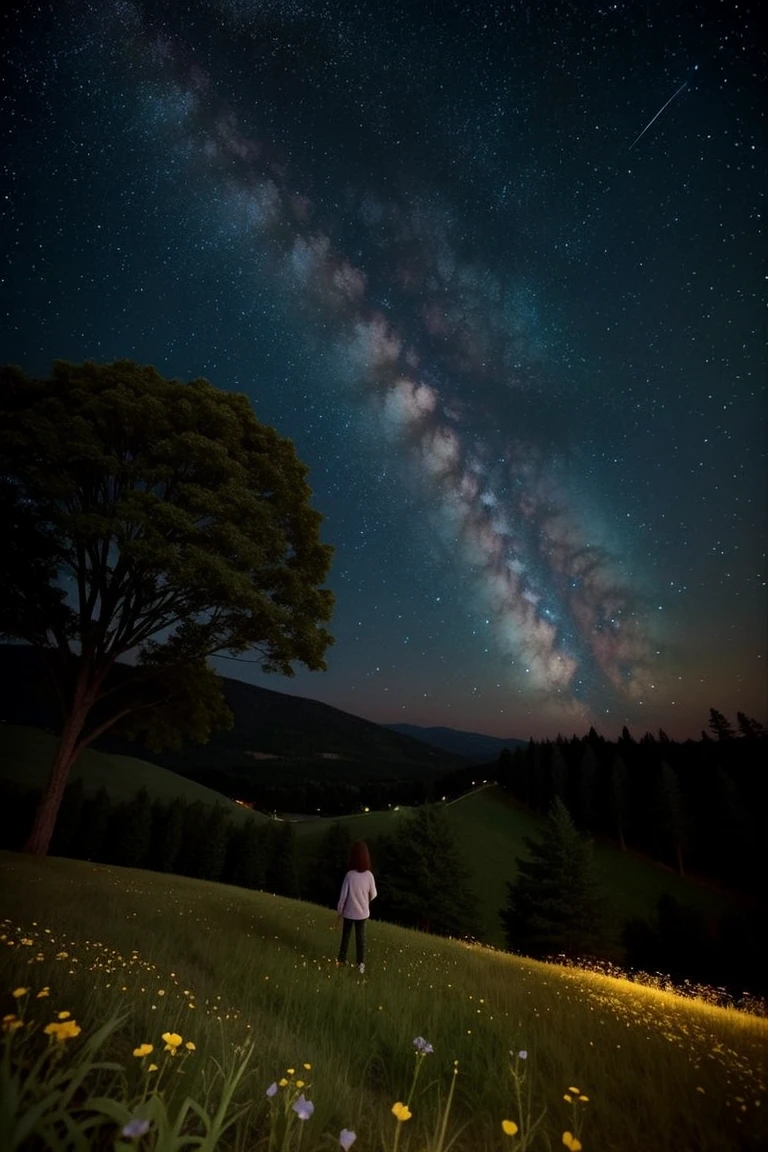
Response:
[500,799,607,957]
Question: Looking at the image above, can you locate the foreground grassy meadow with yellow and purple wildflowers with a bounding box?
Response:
[0,854,768,1152]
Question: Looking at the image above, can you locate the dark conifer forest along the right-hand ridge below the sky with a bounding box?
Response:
[497,708,768,894]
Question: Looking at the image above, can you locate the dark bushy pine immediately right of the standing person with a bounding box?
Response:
[375,804,481,937]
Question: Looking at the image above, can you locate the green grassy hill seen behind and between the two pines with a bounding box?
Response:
[292,786,728,947]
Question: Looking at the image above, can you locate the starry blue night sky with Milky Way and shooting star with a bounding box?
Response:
[0,0,768,737]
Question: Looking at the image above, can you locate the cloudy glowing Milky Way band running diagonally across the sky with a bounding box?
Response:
[3,2,764,729]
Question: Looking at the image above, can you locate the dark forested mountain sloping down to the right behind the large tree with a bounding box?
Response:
[0,644,466,780]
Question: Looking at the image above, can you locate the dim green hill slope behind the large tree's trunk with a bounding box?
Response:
[0,723,268,821]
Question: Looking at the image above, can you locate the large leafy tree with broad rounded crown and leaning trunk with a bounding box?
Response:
[0,361,333,854]
